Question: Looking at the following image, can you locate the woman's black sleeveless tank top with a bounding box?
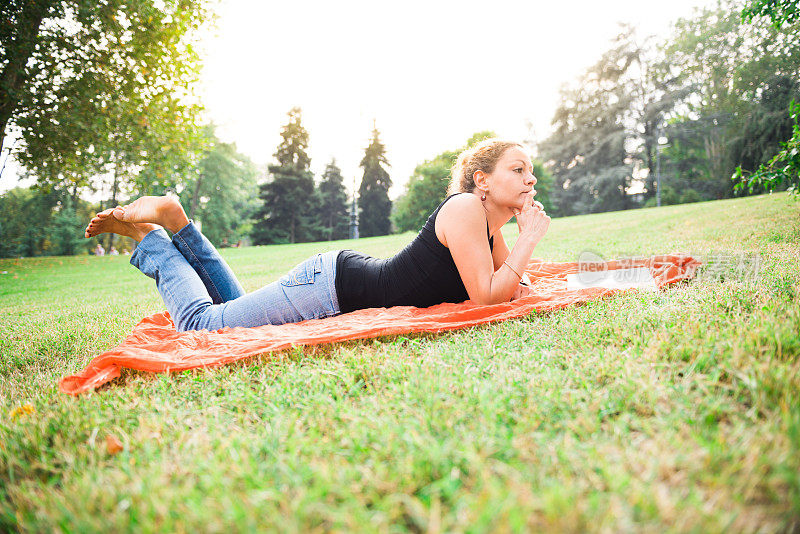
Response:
[336,195,494,313]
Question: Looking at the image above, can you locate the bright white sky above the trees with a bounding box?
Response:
[0,0,715,198]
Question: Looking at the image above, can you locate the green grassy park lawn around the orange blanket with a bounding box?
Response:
[0,194,800,532]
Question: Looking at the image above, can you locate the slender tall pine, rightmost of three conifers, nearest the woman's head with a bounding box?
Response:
[358,127,392,237]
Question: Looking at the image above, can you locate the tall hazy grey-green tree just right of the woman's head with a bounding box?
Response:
[542,25,704,215]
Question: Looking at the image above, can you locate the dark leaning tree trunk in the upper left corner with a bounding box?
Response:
[0,0,52,153]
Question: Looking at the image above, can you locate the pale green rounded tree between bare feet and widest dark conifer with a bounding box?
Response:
[180,126,258,246]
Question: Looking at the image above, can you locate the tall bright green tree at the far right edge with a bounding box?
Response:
[665,1,800,198]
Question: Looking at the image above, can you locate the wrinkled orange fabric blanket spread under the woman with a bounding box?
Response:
[59,254,700,395]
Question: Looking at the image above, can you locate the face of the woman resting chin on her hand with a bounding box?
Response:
[487,147,536,209]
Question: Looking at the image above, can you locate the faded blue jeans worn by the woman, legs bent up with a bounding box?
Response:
[131,223,340,332]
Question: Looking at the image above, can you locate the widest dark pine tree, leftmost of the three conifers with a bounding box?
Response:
[252,108,317,245]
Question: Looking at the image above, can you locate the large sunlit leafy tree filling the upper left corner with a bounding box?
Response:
[0,0,207,203]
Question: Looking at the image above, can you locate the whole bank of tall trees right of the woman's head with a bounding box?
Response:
[541,0,800,215]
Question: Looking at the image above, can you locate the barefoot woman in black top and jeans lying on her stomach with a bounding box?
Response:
[86,139,550,331]
